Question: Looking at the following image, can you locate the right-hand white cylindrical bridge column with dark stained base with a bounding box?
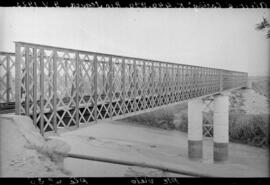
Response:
[213,96,229,162]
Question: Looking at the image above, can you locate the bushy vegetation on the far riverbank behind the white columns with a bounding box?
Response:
[122,98,270,147]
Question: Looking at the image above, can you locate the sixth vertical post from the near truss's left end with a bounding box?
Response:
[75,51,80,127]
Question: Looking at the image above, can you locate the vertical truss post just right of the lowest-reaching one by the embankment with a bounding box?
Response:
[53,49,57,133]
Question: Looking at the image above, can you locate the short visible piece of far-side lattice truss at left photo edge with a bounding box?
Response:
[0,51,15,109]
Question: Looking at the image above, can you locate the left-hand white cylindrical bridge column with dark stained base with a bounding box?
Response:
[188,98,203,160]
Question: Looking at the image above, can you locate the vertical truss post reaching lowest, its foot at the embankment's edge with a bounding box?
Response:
[40,49,44,136]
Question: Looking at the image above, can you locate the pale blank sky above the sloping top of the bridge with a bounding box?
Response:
[0,7,270,76]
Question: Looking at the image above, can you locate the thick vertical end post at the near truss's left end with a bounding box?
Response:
[15,42,22,115]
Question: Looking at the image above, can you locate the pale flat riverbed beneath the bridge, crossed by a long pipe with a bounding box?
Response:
[47,121,268,177]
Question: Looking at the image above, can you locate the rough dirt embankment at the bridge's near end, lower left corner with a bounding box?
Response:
[0,115,67,177]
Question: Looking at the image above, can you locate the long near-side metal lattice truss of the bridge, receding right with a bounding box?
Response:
[15,42,247,133]
